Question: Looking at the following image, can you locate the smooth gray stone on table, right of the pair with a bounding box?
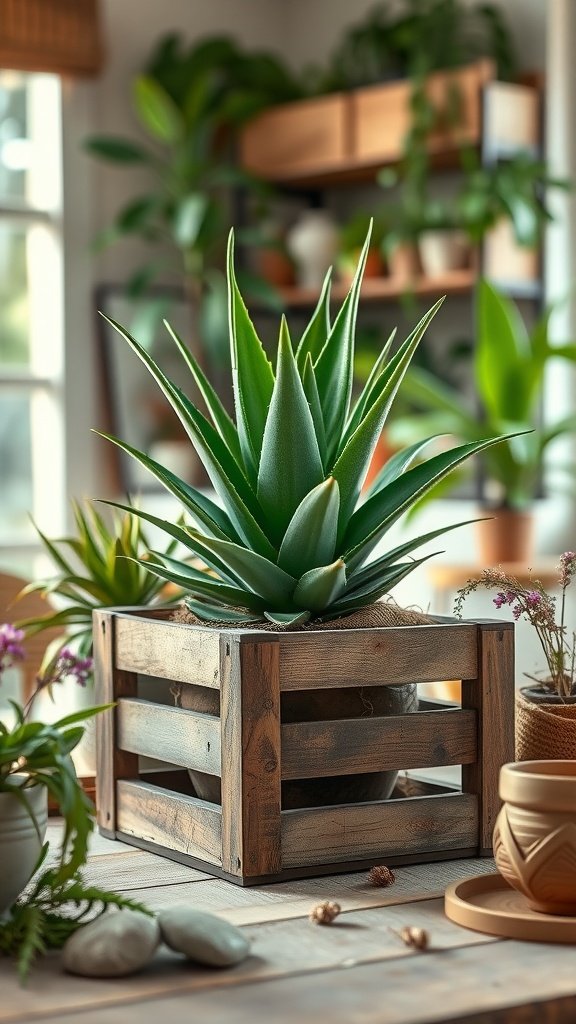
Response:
[158,906,250,967]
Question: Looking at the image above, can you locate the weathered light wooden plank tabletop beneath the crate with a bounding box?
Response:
[0,823,576,1024]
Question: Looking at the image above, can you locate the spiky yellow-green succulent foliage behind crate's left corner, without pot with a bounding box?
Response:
[16,502,179,675]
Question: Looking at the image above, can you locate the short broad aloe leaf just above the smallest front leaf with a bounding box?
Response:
[278,476,340,579]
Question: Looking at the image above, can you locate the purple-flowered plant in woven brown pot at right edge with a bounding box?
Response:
[454,551,576,761]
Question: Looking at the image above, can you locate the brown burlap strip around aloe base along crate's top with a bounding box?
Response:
[173,599,434,633]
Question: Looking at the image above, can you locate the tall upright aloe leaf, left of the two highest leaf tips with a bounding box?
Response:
[228,231,274,476]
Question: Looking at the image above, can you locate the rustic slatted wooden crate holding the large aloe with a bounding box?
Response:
[94,609,513,885]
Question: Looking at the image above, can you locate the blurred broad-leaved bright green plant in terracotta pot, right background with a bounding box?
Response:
[395,281,576,565]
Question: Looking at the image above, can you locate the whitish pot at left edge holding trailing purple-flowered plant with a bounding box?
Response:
[0,775,48,914]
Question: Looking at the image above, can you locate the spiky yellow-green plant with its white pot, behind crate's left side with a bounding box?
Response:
[16,502,179,775]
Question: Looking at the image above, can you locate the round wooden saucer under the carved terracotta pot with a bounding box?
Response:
[444,874,576,943]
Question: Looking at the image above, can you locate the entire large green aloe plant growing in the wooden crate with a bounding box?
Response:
[98,228,506,628]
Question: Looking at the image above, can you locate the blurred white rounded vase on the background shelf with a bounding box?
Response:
[286,210,338,289]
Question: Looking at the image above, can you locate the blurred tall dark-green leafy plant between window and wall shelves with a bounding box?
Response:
[86,35,301,372]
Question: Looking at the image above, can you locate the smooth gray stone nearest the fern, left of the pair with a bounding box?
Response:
[63,910,160,978]
